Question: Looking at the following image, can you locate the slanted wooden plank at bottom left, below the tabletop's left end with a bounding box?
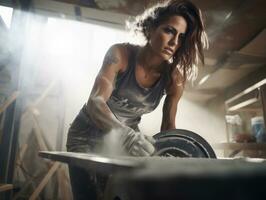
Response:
[29,162,60,200]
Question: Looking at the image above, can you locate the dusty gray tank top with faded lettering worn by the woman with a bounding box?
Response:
[107,44,167,129]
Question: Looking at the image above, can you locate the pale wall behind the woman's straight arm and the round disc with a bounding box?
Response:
[140,92,226,157]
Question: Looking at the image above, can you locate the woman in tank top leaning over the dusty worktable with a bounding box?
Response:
[67,0,207,199]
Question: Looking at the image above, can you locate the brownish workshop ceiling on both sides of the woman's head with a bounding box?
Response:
[14,0,266,102]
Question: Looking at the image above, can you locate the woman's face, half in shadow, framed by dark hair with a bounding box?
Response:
[150,16,187,60]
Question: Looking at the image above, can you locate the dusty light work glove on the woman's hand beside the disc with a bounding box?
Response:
[120,126,155,156]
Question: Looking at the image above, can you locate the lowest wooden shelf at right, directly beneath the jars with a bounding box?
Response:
[212,142,266,151]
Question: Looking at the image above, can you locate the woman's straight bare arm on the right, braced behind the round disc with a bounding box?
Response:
[161,69,184,131]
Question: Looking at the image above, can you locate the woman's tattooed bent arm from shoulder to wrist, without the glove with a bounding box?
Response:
[86,44,128,131]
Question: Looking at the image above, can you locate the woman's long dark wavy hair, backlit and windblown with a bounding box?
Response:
[133,0,208,81]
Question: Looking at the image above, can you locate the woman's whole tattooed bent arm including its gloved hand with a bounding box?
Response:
[86,45,155,156]
